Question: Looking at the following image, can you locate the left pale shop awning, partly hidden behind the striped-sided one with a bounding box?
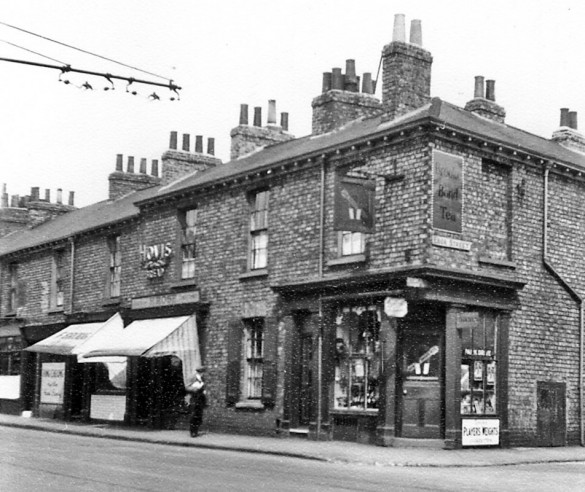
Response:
[25,314,123,355]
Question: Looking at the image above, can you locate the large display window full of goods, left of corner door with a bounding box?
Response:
[333,306,382,410]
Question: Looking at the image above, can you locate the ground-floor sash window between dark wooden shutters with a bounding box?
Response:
[244,318,264,400]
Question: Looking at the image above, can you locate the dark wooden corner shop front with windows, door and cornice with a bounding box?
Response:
[281,268,520,448]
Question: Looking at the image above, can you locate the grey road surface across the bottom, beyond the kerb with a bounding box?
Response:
[0,427,585,492]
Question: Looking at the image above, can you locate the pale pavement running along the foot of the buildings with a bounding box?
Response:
[0,414,585,468]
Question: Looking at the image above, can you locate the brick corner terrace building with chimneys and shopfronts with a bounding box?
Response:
[0,16,585,447]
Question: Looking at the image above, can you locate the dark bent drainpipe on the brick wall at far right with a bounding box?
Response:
[542,164,585,446]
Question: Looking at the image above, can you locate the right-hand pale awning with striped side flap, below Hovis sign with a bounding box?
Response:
[75,315,201,386]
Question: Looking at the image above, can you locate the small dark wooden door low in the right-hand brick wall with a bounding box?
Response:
[536,381,567,446]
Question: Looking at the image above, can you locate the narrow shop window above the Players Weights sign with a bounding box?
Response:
[461,313,498,415]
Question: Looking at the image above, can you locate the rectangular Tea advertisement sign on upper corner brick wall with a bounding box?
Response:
[433,150,463,232]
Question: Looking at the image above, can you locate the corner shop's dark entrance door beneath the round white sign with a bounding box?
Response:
[397,311,444,439]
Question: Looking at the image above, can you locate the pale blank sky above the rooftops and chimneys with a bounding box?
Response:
[0,0,585,206]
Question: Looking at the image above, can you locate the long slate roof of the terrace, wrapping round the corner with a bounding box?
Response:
[0,98,585,255]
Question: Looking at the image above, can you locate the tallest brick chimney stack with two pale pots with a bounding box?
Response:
[382,14,433,121]
